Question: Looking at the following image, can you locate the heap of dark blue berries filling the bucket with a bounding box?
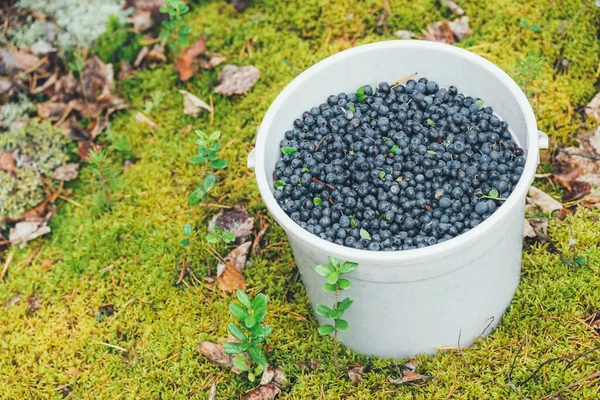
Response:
[273,78,525,251]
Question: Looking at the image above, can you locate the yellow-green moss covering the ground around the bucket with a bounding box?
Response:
[0,0,600,399]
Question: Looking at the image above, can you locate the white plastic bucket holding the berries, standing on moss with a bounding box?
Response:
[248,40,547,358]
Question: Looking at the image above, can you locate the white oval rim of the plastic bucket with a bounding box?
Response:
[255,40,539,265]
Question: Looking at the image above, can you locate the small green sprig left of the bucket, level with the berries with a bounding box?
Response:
[188,130,227,211]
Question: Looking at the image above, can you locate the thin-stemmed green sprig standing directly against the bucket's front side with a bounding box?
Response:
[315,257,358,371]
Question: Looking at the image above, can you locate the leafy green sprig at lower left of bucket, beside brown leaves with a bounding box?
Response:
[223,290,273,382]
